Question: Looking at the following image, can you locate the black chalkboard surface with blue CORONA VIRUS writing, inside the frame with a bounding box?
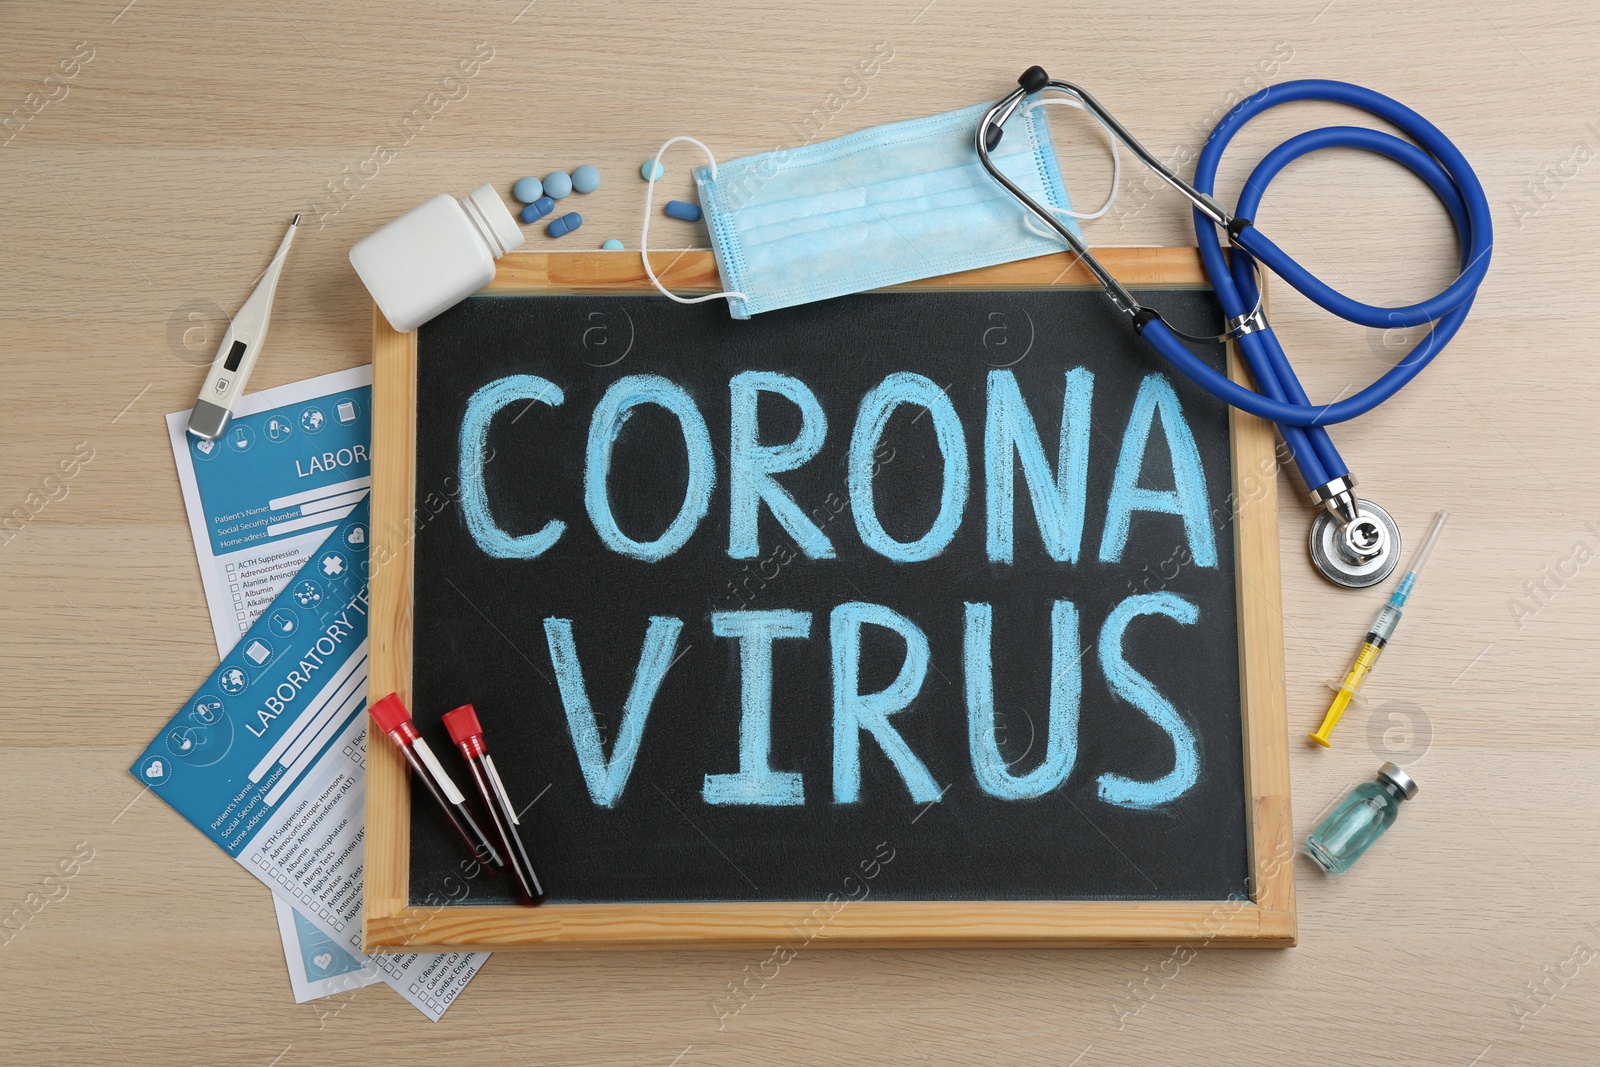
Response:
[360,258,1282,953]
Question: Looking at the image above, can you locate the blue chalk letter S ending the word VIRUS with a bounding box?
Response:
[1098,592,1200,808]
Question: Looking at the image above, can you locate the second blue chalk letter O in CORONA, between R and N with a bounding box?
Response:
[848,371,970,563]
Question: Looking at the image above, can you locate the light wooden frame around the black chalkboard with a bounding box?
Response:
[362,248,1296,952]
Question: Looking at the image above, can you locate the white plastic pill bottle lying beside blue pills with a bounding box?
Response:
[350,186,526,333]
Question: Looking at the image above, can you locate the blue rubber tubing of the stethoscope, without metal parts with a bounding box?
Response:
[1141,78,1494,486]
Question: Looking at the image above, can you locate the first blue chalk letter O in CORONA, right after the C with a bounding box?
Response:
[584,374,717,563]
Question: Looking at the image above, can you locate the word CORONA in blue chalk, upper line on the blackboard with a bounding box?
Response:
[458,368,1218,568]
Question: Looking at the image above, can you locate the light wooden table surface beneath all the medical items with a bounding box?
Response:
[0,0,1600,1067]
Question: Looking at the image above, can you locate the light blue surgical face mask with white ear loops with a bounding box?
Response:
[640,99,1115,318]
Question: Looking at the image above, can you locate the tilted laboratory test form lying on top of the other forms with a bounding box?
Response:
[128,501,488,1021]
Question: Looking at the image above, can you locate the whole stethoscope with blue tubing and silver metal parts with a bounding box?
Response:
[976,67,1494,589]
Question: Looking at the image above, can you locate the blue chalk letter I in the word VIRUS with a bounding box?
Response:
[701,611,811,806]
